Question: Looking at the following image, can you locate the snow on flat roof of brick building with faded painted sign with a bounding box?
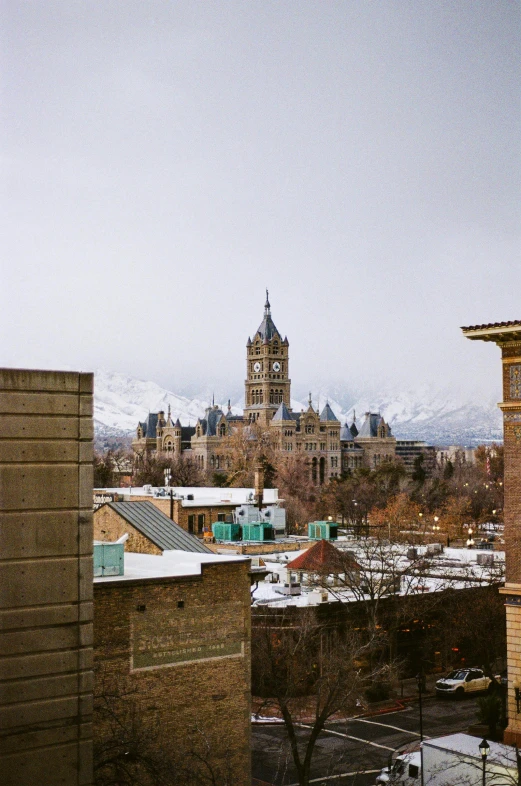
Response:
[94,551,249,584]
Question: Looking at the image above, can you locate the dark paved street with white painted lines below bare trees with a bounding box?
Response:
[252,696,479,786]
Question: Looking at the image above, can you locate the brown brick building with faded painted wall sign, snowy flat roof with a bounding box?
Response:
[94,548,251,786]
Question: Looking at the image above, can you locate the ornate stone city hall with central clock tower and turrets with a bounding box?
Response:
[132,292,402,483]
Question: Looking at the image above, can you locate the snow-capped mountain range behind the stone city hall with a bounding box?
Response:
[94,370,502,446]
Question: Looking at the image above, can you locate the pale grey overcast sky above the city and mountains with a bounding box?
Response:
[0,0,521,395]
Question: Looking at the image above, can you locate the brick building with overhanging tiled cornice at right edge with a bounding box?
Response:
[462,321,521,745]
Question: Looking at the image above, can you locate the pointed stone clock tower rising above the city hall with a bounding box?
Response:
[244,290,291,426]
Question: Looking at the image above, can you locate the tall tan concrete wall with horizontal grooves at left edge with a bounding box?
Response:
[0,369,93,786]
